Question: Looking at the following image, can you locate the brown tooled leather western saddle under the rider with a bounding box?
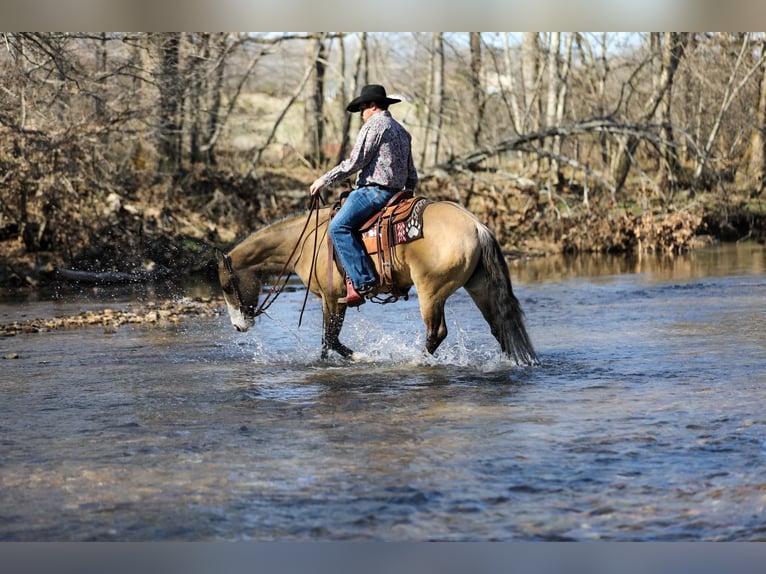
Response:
[328,191,431,303]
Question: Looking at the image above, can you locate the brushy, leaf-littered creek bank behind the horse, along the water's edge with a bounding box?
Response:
[0,170,766,291]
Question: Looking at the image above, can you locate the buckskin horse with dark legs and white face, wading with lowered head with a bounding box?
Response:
[218,201,538,365]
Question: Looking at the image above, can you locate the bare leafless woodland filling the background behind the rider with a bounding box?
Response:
[0,32,766,272]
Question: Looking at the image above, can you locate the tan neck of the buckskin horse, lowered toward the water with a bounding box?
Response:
[231,214,327,271]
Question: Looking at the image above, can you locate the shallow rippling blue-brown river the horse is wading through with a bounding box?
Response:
[0,244,766,541]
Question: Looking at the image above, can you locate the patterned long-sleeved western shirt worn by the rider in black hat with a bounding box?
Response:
[322,110,418,190]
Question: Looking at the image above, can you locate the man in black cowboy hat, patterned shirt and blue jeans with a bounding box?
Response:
[309,84,418,307]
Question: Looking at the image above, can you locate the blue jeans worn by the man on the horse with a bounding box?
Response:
[330,186,395,289]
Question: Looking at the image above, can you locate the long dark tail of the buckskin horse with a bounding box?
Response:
[465,223,540,365]
